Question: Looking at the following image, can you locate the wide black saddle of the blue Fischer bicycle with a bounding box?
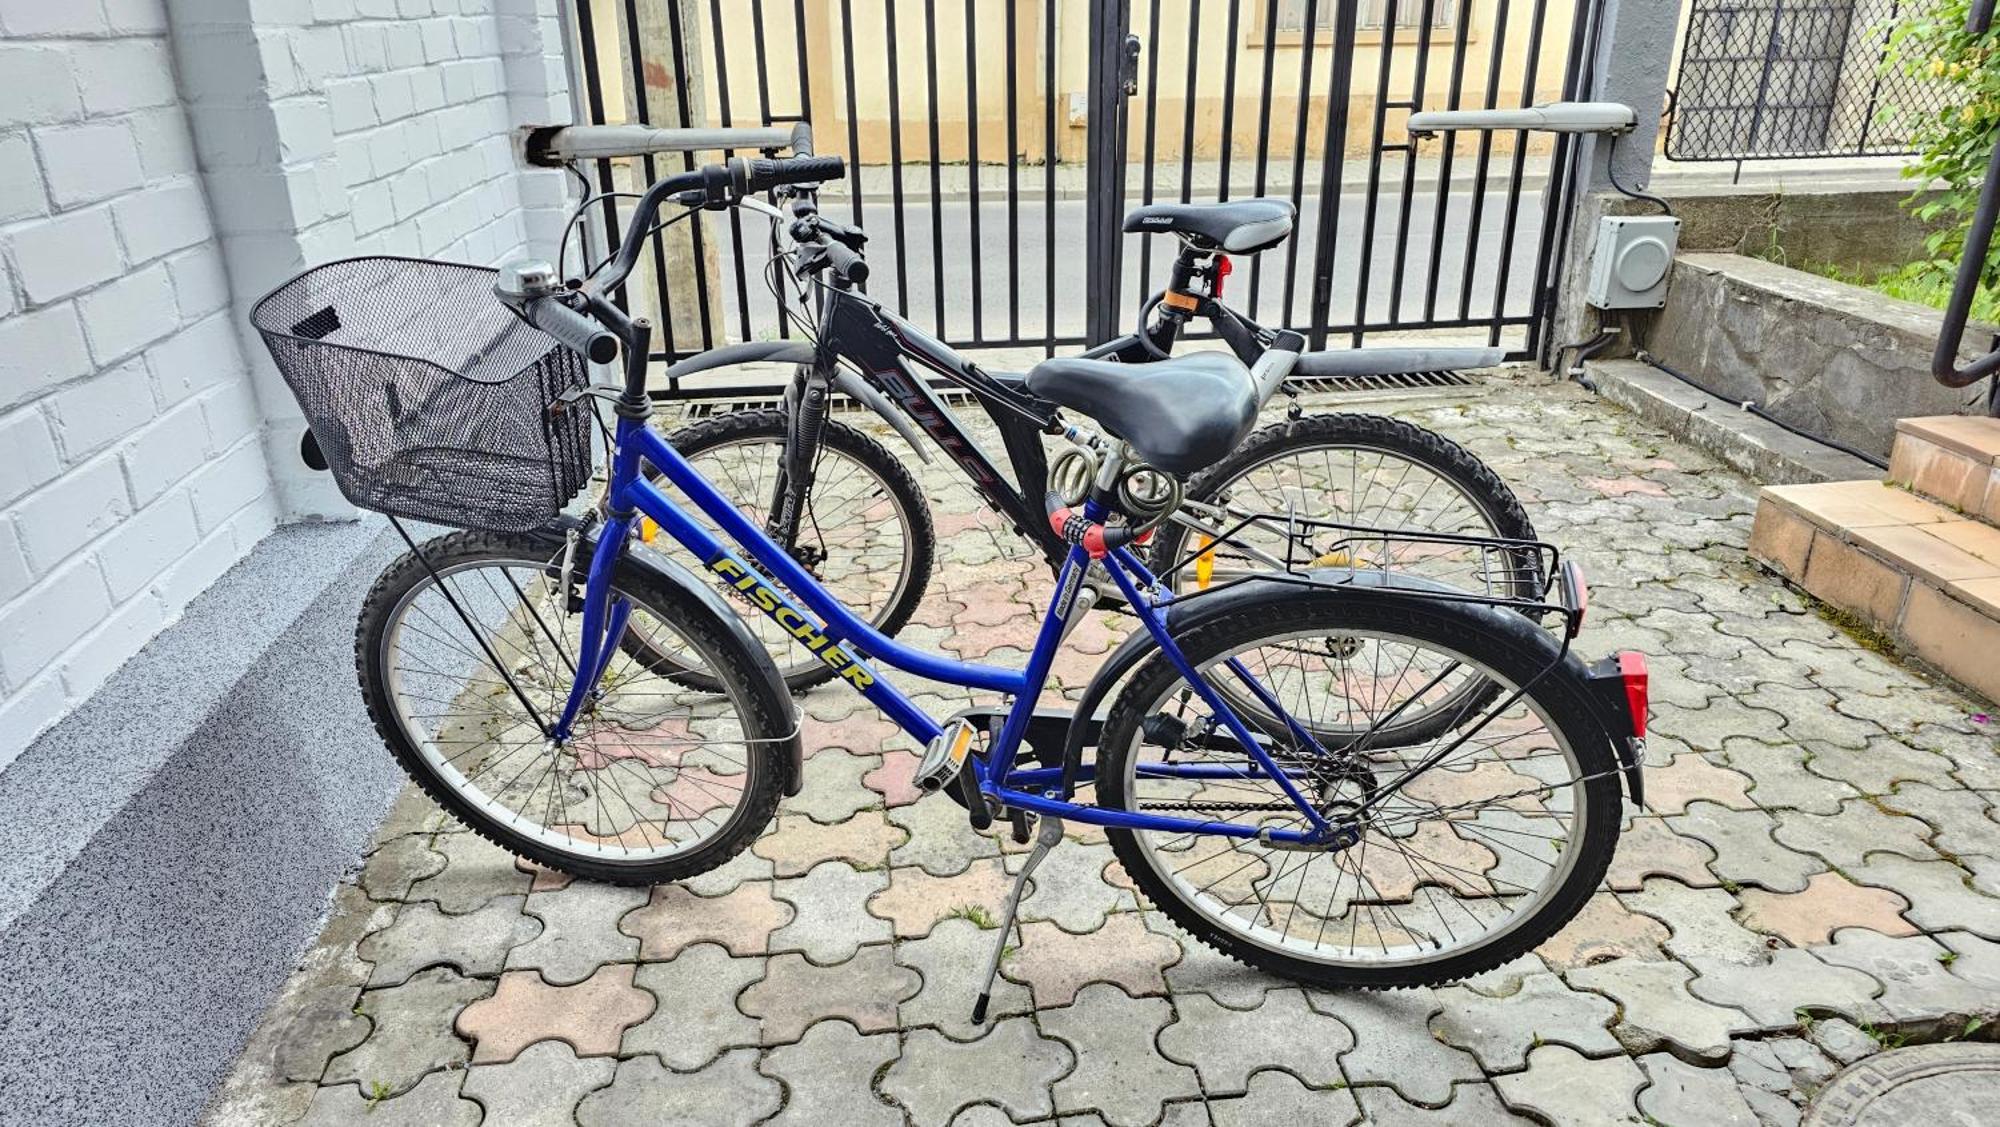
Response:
[1028,352,1258,474]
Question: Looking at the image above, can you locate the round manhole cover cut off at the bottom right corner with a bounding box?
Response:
[1802,1045,2000,1127]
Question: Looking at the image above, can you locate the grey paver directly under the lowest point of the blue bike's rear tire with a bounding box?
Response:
[1308,989,1484,1107]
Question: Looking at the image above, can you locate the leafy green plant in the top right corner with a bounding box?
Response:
[1884,0,2000,290]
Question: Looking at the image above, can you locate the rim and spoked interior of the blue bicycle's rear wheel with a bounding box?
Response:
[1122,631,1590,969]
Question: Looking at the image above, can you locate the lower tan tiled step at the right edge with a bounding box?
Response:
[1750,482,2000,701]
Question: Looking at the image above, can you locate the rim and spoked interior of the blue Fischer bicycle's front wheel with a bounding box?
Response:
[378,558,762,863]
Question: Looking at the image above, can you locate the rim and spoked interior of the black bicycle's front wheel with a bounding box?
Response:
[644,436,918,679]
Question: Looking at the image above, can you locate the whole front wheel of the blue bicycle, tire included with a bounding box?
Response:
[354,532,794,885]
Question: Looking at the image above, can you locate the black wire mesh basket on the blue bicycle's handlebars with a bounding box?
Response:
[250,258,592,532]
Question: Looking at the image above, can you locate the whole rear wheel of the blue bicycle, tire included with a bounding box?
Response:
[1096,591,1622,987]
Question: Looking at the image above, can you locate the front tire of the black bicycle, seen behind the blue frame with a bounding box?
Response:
[624,408,938,693]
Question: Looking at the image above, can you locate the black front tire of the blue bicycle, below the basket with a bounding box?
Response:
[354,532,794,885]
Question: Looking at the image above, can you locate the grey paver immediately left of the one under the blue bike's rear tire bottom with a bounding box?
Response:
[1160,987,1354,1095]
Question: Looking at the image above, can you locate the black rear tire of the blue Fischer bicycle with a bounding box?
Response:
[1096,593,1622,989]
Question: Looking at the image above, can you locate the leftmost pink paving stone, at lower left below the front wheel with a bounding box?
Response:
[454,963,654,1065]
